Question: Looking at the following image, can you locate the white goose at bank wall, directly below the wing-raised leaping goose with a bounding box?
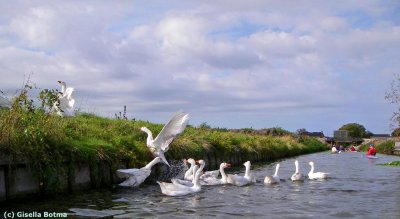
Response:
[117,157,161,187]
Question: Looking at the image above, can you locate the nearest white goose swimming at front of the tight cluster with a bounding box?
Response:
[157,160,205,196]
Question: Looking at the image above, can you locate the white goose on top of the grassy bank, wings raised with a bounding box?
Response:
[52,81,75,117]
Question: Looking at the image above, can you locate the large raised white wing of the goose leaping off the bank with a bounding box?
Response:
[153,111,189,152]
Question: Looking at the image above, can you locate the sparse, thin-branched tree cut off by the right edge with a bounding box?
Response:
[385,74,400,128]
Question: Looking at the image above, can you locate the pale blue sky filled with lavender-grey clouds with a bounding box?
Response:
[0,0,400,136]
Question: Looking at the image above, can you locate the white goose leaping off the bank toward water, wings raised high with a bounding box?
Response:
[140,111,189,166]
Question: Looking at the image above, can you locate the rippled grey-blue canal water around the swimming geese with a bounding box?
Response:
[0,152,400,219]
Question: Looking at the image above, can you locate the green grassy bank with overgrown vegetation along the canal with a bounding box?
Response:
[0,84,327,190]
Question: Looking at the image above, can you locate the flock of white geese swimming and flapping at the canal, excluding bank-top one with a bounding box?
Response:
[117,111,329,196]
